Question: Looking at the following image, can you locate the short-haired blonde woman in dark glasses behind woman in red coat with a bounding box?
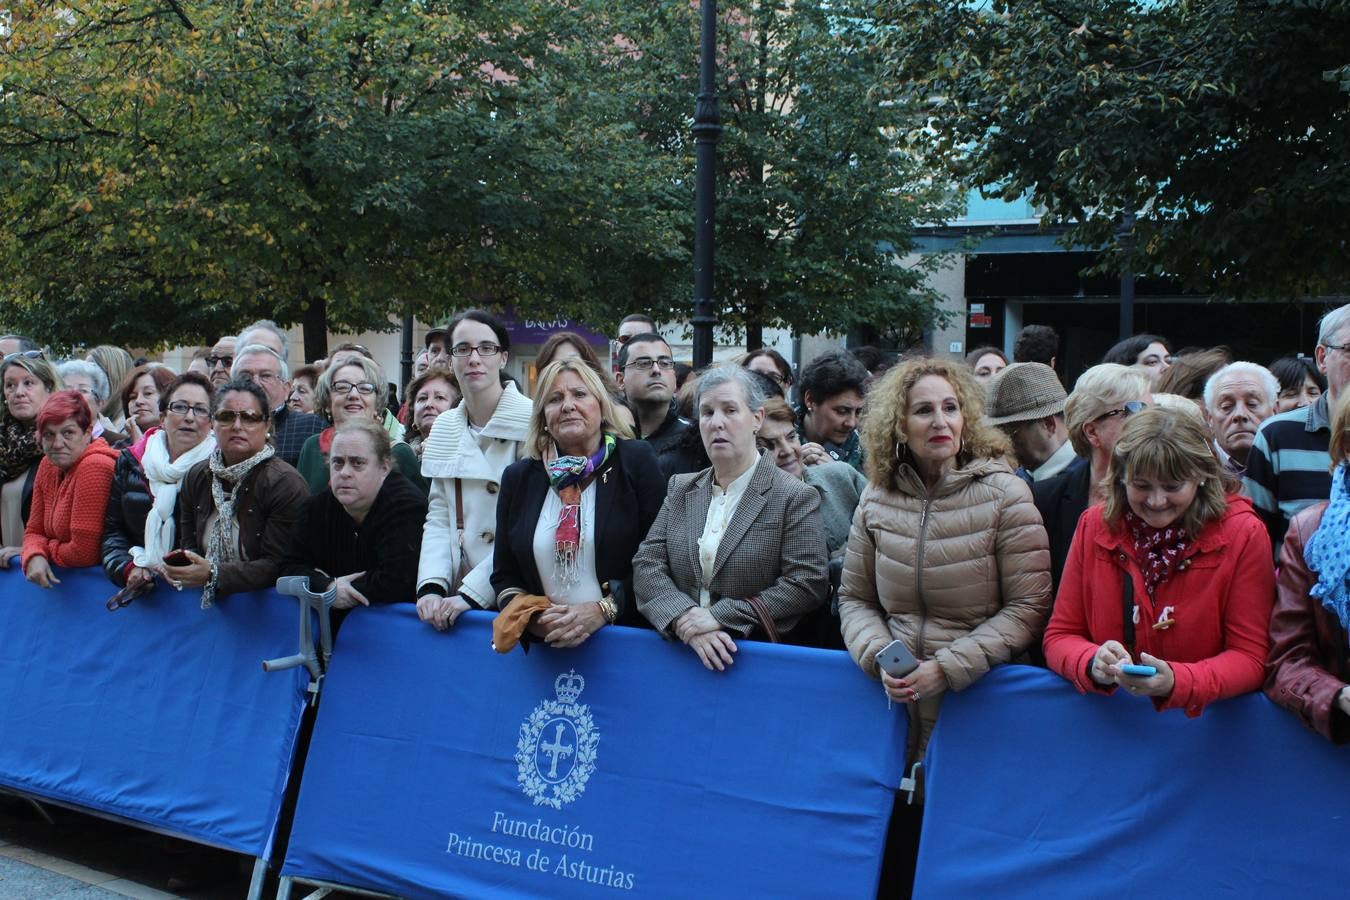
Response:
[1031,363,1153,586]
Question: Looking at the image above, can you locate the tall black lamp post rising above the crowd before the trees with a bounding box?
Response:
[694,0,722,368]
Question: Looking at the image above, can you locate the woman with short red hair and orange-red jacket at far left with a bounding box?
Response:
[23,390,117,587]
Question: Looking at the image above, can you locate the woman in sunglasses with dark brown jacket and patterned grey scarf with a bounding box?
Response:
[158,379,309,609]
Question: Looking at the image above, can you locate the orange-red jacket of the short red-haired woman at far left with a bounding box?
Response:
[23,437,117,572]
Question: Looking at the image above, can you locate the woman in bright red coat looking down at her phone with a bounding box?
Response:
[1045,407,1274,716]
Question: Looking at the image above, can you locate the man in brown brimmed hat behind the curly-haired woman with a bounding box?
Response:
[984,363,1075,482]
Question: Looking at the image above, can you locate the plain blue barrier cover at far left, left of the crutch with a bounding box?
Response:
[0,568,308,858]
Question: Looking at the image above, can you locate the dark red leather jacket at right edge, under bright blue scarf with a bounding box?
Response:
[1266,503,1350,743]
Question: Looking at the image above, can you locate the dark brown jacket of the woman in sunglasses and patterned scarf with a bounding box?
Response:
[178,456,309,596]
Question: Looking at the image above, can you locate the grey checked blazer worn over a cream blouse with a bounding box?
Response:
[633,455,829,637]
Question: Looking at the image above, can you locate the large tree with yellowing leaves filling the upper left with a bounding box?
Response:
[0,0,687,359]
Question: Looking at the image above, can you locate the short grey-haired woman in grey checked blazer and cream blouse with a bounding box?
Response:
[633,366,829,671]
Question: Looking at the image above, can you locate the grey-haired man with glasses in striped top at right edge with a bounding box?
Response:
[1242,304,1350,557]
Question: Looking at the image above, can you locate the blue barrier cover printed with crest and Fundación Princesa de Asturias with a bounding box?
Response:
[282,606,905,897]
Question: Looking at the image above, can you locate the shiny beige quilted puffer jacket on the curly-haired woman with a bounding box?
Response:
[838,459,1050,762]
